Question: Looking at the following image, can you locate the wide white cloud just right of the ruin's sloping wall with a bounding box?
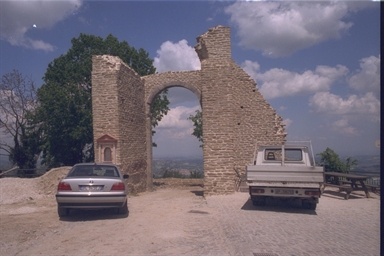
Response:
[241,60,348,99]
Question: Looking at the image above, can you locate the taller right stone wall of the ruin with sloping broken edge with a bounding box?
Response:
[195,26,286,194]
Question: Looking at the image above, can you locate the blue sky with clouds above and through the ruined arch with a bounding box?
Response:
[0,0,380,160]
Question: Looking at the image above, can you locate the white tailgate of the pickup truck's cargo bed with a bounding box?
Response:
[247,165,324,183]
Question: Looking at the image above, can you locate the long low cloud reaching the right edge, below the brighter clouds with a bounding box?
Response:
[309,92,380,115]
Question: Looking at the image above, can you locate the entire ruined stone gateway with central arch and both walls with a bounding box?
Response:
[92,26,286,195]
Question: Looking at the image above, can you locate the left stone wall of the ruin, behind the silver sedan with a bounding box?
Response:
[92,55,147,192]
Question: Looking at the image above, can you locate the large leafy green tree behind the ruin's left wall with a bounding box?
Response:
[34,34,168,167]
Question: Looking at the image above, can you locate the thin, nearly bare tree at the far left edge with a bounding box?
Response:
[0,70,41,169]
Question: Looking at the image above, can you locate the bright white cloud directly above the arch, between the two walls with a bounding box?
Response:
[153,39,200,73]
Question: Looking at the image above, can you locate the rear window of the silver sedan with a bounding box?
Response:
[67,165,119,177]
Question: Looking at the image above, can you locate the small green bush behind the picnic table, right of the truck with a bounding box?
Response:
[317,148,358,173]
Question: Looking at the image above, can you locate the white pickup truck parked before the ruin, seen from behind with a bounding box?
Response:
[246,141,324,210]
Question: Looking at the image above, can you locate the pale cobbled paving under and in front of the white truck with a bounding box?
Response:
[195,191,380,256]
